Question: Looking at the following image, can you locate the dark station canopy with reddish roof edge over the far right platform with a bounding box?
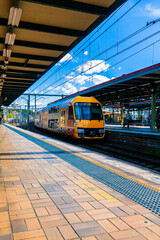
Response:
[75,63,160,105]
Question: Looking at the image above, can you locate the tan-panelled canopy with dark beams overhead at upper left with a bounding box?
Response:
[0,0,126,106]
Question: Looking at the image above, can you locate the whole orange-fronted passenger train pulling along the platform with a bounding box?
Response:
[34,96,105,139]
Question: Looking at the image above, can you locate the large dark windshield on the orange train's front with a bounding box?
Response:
[74,102,103,120]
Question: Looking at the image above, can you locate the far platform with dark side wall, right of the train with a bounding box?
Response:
[105,124,160,158]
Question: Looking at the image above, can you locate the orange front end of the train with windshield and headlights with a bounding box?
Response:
[72,97,105,139]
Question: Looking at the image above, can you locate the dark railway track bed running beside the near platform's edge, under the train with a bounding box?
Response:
[20,126,160,173]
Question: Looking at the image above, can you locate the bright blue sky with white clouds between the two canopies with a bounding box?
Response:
[14,0,160,107]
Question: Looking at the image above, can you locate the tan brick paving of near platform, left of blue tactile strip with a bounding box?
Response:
[0,126,160,240]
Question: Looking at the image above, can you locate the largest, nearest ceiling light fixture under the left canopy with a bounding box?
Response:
[8,7,22,27]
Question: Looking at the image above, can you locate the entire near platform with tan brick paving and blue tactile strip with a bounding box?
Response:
[0,125,160,240]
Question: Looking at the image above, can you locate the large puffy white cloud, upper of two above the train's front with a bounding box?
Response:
[77,60,110,74]
